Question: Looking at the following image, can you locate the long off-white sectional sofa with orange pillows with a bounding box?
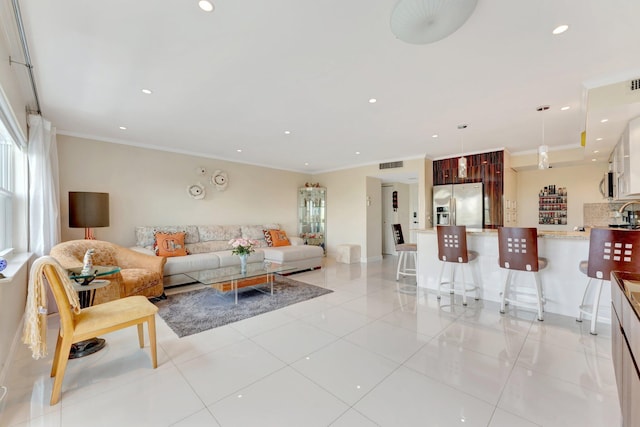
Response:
[132,224,324,288]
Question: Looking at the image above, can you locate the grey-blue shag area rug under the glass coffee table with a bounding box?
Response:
[155,275,333,338]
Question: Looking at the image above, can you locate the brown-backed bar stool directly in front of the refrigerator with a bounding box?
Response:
[436,225,480,305]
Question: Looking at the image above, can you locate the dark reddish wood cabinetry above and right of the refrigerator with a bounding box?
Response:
[433,151,504,228]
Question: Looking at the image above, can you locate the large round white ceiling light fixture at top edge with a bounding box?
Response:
[391,0,478,44]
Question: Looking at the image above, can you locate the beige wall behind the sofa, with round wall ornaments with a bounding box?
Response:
[58,135,312,246]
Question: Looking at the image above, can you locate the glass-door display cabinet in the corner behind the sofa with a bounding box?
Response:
[298,187,327,250]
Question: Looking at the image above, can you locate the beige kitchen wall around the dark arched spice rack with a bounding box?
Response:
[517,163,608,230]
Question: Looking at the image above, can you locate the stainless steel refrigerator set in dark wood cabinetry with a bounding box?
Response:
[433,182,484,228]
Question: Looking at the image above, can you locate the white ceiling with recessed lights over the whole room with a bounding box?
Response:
[11,0,640,173]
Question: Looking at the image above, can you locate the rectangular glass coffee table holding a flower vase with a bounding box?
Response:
[185,263,295,304]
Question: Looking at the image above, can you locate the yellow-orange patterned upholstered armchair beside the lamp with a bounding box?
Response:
[50,240,167,304]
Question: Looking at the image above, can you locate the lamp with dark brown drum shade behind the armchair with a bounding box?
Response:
[69,191,109,240]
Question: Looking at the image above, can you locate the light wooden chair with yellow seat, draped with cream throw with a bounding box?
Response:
[37,263,158,405]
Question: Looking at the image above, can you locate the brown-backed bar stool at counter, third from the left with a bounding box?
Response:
[498,227,547,321]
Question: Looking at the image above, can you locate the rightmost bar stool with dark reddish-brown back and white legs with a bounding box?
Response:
[576,228,640,335]
